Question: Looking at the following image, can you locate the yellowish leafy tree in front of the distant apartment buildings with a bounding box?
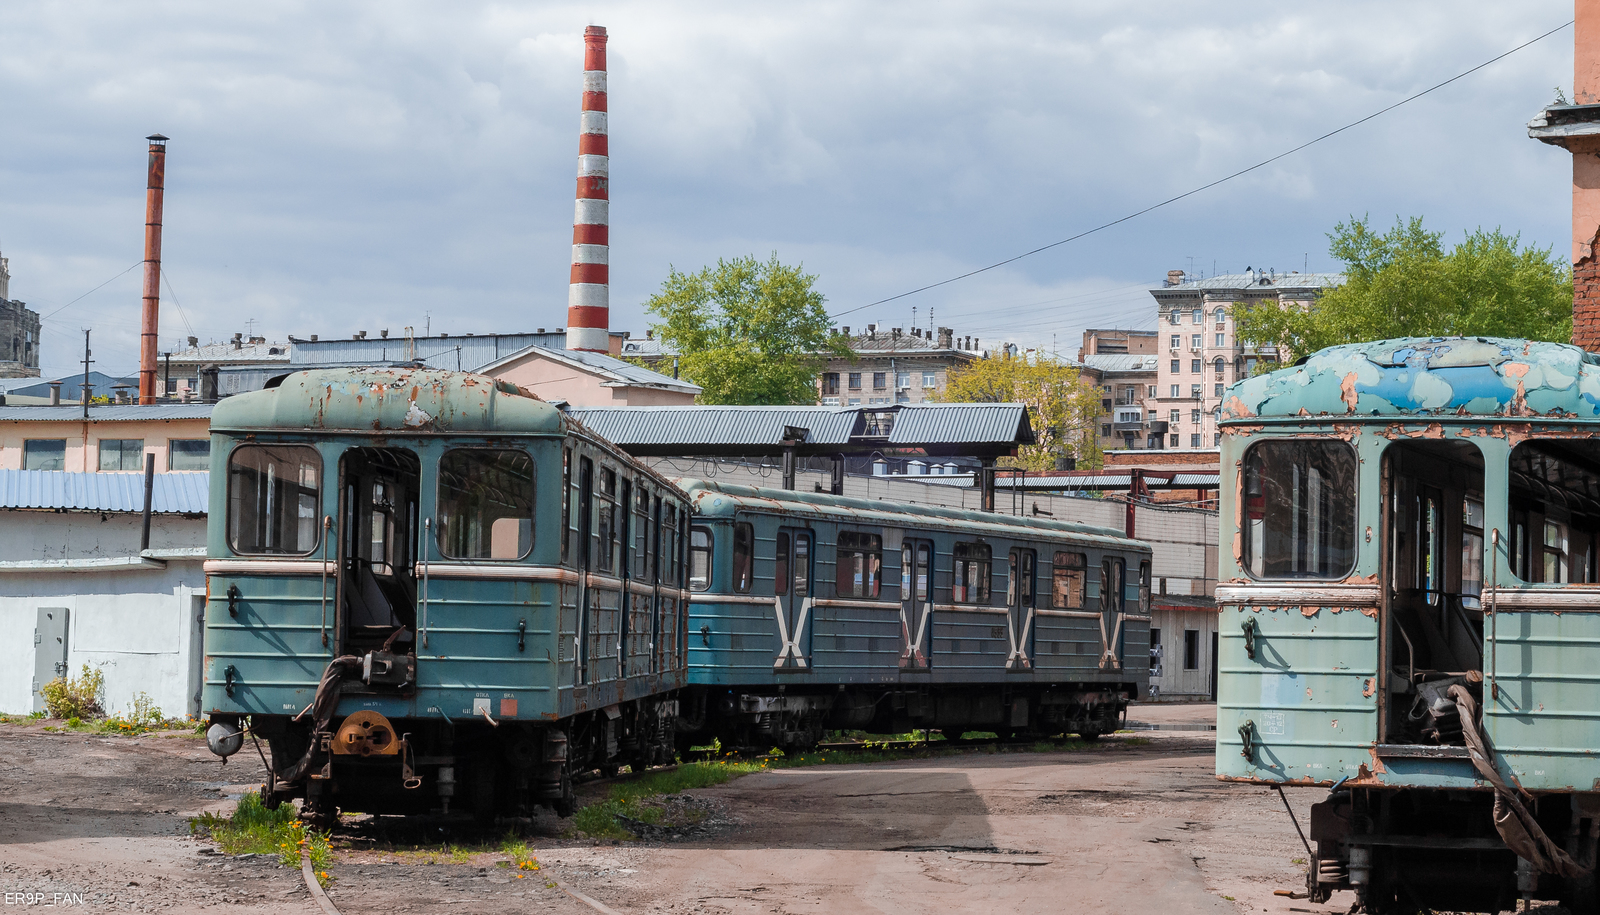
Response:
[939,350,1101,470]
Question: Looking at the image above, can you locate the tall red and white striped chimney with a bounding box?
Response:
[566,26,611,352]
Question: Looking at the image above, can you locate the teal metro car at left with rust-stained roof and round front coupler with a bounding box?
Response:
[203,370,688,822]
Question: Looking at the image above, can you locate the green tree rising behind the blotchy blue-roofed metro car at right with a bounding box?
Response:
[1237,216,1573,360]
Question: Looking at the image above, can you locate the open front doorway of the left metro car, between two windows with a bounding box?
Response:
[338,448,421,668]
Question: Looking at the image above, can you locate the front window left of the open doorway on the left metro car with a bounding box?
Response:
[227,445,322,555]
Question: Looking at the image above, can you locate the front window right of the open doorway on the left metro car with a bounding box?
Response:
[438,448,533,560]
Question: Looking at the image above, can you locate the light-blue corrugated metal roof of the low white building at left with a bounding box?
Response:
[0,470,211,515]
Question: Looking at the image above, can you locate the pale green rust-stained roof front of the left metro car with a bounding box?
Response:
[211,368,566,435]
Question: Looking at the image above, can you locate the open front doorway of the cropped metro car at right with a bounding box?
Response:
[1379,442,1485,745]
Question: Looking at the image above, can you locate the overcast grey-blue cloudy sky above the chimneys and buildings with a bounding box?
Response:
[0,0,1573,376]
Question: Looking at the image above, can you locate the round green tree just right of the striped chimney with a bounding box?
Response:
[645,253,851,403]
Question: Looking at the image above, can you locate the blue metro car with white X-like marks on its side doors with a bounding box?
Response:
[678,480,1150,749]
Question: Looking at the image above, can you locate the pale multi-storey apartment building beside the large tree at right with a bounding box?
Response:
[1146,269,1344,450]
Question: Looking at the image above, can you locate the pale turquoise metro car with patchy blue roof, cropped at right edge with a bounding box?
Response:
[1216,338,1600,912]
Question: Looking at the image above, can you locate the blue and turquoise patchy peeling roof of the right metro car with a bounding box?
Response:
[1219,338,1600,426]
